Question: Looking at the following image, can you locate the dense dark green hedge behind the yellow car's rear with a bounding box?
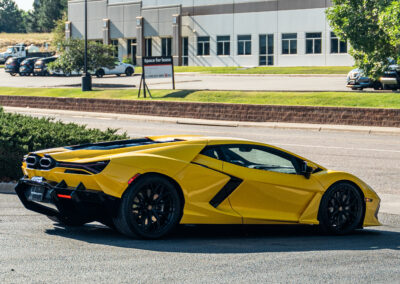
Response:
[0,107,127,181]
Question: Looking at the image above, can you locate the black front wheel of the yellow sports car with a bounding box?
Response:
[319,182,364,235]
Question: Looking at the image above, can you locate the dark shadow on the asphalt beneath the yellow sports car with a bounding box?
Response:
[46,223,400,254]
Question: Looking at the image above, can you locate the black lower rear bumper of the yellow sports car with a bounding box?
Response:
[15,179,120,222]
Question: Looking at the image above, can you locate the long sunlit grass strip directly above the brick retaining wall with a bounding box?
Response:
[0,88,400,108]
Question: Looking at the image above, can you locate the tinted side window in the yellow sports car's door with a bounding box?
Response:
[220,145,297,174]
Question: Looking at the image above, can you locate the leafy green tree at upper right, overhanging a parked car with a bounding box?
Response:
[327,0,399,79]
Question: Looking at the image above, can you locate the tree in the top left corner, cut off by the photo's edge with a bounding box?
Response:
[0,0,25,33]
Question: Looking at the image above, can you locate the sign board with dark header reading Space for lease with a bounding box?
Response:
[143,56,174,79]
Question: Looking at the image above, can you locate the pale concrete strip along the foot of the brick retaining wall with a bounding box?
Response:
[3,106,400,135]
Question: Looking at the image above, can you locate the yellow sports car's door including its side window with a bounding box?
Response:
[217,144,322,224]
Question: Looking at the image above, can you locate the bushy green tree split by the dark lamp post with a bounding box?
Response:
[49,39,115,74]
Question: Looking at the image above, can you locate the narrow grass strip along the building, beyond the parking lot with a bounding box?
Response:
[135,66,353,75]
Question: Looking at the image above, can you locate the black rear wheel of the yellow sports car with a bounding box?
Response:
[113,175,182,239]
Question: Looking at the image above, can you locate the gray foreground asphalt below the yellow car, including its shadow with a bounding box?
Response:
[0,194,400,283]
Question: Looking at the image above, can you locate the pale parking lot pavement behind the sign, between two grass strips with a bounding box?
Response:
[0,69,349,91]
